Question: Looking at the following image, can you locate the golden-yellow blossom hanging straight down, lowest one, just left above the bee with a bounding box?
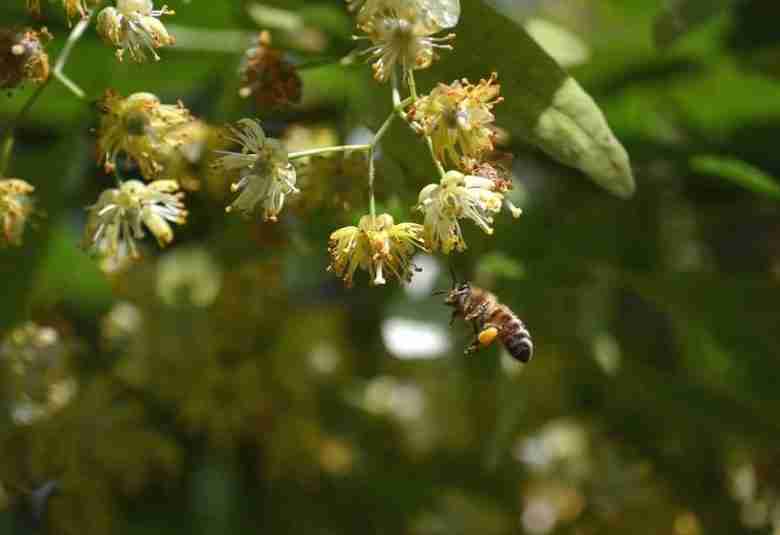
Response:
[328,214,425,287]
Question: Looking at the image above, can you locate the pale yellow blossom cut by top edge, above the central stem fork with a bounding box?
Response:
[350,0,455,82]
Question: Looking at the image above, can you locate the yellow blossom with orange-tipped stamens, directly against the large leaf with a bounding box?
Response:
[409,73,502,165]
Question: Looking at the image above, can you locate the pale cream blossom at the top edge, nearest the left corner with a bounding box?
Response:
[97,0,175,63]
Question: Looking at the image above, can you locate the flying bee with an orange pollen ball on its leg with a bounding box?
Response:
[440,279,534,362]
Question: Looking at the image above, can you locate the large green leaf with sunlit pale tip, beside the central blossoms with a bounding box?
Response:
[364,0,635,198]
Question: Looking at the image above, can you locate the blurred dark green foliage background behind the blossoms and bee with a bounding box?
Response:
[0,0,780,535]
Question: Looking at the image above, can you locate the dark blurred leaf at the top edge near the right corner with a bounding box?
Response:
[653,0,734,48]
